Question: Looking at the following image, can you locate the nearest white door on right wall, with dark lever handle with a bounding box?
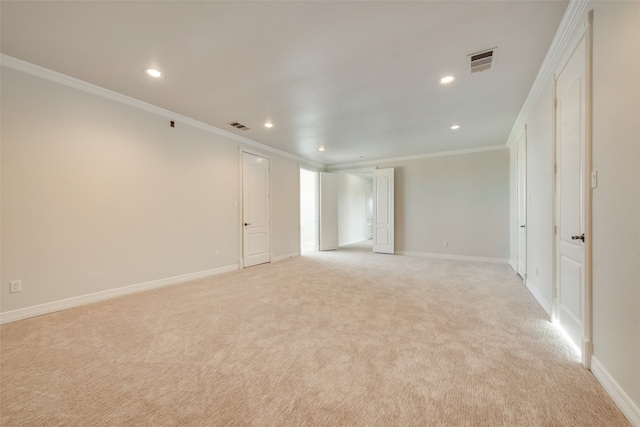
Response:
[554,39,586,358]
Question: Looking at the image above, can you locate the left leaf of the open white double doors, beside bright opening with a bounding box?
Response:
[320,172,338,251]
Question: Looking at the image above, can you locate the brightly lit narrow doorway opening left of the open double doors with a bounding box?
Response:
[300,168,318,255]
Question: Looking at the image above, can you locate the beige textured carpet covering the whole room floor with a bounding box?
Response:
[0,246,628,426]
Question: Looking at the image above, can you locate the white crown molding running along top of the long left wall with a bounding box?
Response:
[0,54,324,168]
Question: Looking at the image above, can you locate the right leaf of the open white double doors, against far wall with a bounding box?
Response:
[373,168,395,254]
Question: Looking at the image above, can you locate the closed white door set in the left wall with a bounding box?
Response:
[242,152,271,267]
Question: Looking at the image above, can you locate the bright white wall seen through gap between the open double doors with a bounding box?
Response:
[338,174,370,246]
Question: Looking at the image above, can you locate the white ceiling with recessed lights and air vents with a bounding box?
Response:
[0,0,568,165]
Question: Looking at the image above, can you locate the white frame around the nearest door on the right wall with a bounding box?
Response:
[551,10,593,369]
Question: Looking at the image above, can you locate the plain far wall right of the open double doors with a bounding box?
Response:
[336,147,509,261]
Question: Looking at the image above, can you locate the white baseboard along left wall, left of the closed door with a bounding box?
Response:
[0,265,238,324]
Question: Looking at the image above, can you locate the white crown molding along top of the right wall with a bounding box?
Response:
[507,0,589,146]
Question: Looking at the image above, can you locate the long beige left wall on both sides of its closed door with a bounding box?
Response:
[0,66,299,314]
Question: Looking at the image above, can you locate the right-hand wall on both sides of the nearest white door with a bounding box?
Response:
[509,1,640,425]
